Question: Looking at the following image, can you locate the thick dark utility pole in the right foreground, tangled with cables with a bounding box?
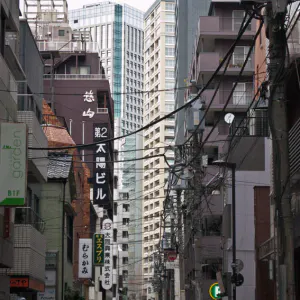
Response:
[267,5,295,300]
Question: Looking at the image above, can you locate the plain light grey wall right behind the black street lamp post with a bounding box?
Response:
[224,139,271,299]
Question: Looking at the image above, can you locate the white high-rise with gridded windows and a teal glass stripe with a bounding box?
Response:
[69,1,144,134]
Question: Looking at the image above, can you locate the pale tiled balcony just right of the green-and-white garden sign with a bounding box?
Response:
[18,111,48,182]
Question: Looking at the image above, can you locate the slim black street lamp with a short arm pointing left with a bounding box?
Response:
[212,160,237,300]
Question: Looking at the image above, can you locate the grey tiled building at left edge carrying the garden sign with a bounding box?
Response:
[0,1,48,299]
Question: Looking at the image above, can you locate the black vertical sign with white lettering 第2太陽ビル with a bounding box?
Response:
[93,123,110,207]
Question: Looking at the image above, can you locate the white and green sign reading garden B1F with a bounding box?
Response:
[0,123,27,206]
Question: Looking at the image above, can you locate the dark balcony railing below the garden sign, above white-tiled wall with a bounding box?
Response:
[15,207,45,233]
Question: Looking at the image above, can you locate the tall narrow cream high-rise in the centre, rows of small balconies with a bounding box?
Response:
[143,0,179,299]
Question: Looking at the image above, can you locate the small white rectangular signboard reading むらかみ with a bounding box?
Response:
[78,239,93,278]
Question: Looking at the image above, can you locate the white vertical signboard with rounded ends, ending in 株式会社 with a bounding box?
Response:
[102,219,113,290]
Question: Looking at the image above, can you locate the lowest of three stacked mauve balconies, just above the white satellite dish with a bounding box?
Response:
[202,89,254,112]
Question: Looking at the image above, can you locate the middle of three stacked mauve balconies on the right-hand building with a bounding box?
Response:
[194,52,254,77]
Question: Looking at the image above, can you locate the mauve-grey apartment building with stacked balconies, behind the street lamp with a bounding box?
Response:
[176,1,270,299]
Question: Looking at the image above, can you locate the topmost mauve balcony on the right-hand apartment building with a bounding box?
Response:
[198,16,256,40]
